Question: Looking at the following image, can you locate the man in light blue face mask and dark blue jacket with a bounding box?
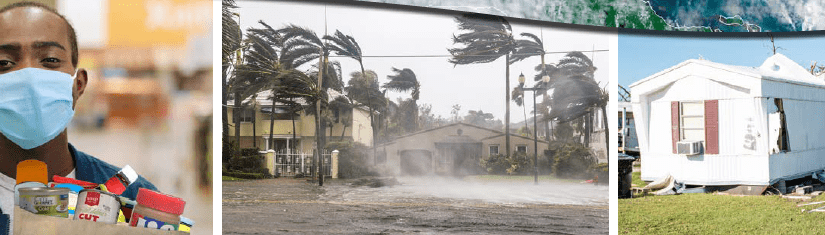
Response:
[0,2,157,229]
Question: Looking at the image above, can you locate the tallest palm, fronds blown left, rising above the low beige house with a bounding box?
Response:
[447,14,518,155]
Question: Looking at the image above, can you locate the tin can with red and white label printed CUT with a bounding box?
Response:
[74,189,120,224]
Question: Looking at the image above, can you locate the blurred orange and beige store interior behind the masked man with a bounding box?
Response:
[0,0,213,234]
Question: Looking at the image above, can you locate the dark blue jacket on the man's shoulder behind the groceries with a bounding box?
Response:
[69,144,157,200]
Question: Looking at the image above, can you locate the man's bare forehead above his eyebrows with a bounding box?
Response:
[0,7,69,47]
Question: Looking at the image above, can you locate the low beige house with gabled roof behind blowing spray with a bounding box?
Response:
[375,123,547,175]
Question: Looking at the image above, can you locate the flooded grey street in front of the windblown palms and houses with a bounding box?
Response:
[223,178,608,234]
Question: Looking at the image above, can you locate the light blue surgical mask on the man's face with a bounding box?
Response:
[0,68,77,149]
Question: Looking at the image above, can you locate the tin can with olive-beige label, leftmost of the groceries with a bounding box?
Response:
[19,187,69,218]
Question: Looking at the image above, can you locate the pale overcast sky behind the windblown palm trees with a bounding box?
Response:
[236,1,615,123]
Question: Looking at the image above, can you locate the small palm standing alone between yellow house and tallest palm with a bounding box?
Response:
[381,67,421,132]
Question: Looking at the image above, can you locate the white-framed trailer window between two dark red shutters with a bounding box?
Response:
[679,101,705,141]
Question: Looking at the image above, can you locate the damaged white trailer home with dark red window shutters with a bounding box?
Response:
[630,54,825,194]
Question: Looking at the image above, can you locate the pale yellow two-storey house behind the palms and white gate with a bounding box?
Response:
[227,90,372,153]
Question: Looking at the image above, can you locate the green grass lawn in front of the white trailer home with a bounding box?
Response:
[619,193,825,234]
